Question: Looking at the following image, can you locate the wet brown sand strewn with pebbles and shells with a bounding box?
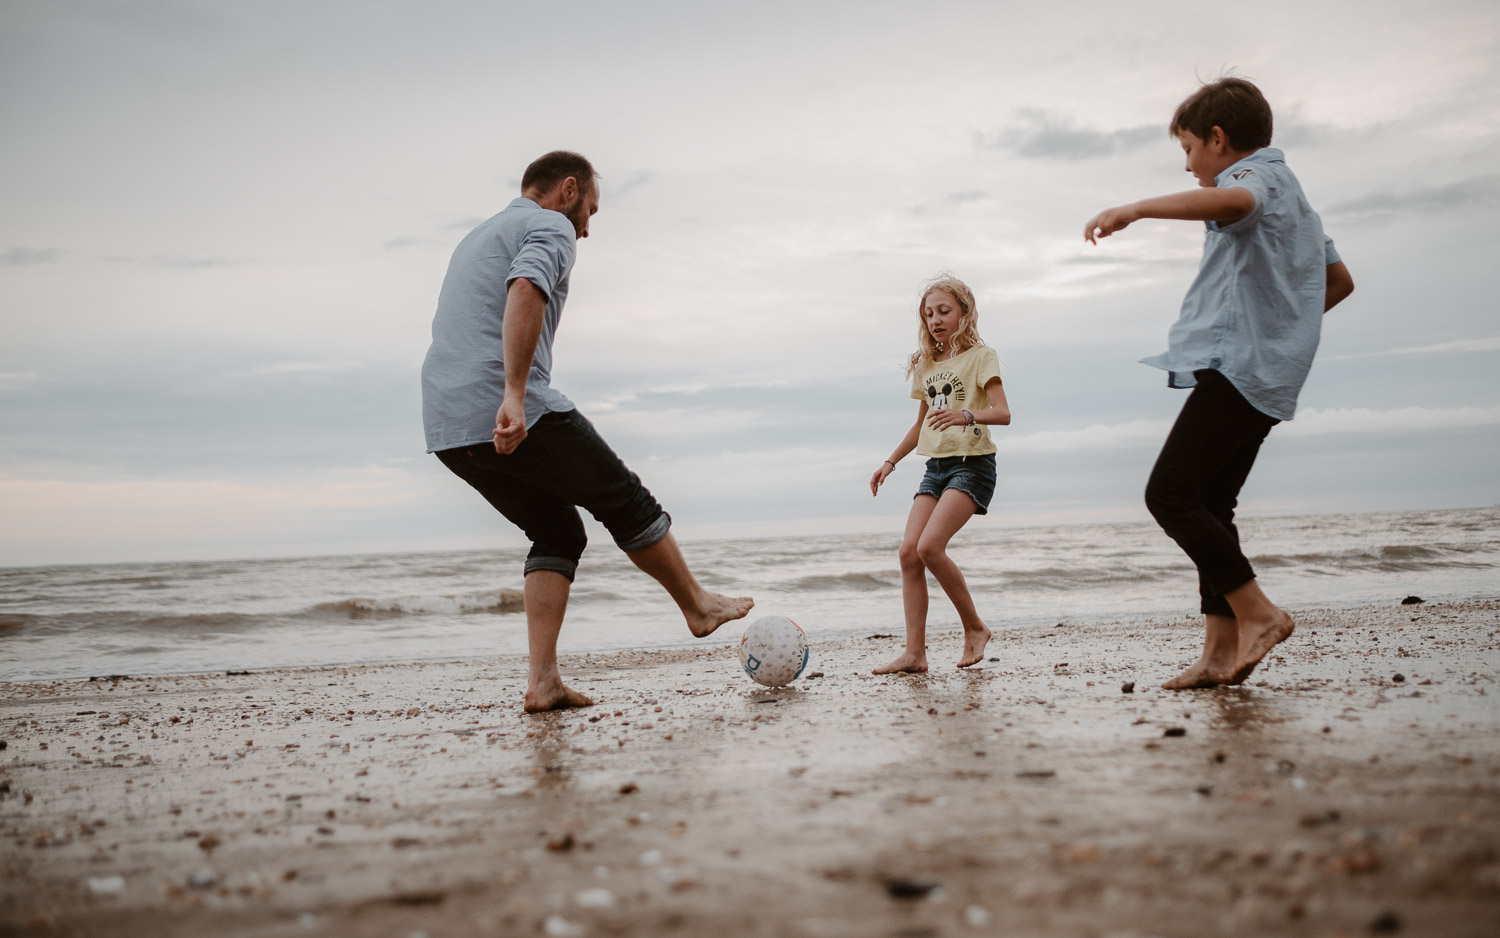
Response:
[0,600,1500,938]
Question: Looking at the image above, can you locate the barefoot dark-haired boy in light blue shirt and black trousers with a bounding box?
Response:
[1083,78,1355,690]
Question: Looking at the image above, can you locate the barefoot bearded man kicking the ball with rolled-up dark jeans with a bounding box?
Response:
[422,150,755,713]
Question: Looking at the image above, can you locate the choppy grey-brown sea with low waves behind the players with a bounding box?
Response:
[0,506,1500,681]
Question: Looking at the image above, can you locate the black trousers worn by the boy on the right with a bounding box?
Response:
[1146,371,1280,617]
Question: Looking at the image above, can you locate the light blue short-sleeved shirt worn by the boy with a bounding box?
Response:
[1142,147,1338,420]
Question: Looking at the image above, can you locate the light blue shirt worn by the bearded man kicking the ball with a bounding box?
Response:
[422,198,578,453]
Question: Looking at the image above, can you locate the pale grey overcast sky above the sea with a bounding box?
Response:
[0,0,1500,564]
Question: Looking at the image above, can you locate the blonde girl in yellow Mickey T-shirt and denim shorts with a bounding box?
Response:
[870,275,1011,674]
